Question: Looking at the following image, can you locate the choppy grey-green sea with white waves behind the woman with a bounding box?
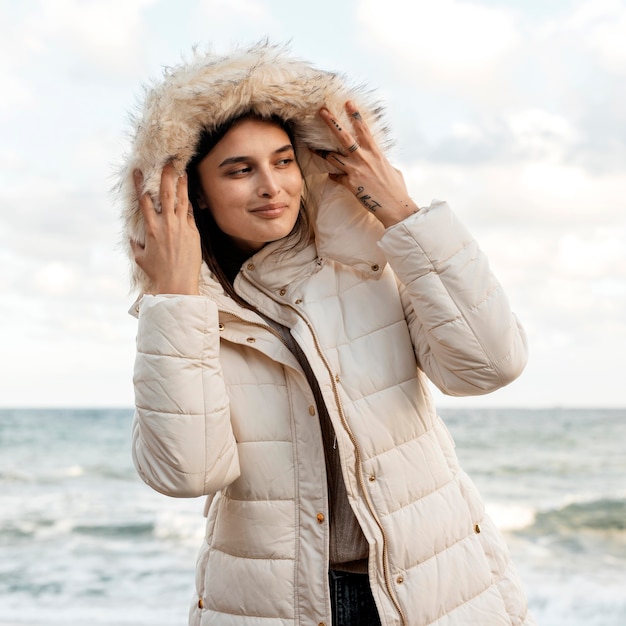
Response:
[0,408,626,626]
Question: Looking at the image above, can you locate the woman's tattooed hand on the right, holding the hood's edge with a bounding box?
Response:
[316,101,419,228]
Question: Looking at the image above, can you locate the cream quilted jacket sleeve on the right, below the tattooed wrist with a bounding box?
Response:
[379,202,528,396]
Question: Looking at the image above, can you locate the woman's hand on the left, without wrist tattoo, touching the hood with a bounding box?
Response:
[130,164,202,295]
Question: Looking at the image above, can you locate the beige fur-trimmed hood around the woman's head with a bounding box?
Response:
[118,42,390,292]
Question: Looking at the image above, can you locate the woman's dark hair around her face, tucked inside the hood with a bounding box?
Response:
[187,111,311,308]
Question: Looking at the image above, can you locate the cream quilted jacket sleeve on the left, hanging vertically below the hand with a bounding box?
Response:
[132,296,239,497]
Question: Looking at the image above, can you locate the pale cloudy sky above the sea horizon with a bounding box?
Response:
[0,0,626,407]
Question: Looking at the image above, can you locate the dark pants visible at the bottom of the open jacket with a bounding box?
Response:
[328,570,380,626]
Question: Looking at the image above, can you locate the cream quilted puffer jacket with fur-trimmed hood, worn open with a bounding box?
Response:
[122,41,533,626]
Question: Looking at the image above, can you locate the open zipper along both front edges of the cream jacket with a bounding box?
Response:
[218,294,407,624]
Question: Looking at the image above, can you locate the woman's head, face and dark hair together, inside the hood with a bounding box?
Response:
[187,114,310,306]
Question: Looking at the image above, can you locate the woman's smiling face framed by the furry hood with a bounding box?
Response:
[198,118,302,253]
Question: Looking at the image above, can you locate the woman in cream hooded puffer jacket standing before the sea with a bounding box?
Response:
[122,44,533,626]
